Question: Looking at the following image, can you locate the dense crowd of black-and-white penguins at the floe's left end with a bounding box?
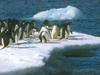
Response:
[0,19,35,48]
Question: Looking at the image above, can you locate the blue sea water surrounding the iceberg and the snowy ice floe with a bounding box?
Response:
[0,0,100,75]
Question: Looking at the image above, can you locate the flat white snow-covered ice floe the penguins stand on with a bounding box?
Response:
[0,32,100,75]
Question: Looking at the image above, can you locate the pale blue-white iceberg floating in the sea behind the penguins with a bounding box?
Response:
[33,6,83,20]
